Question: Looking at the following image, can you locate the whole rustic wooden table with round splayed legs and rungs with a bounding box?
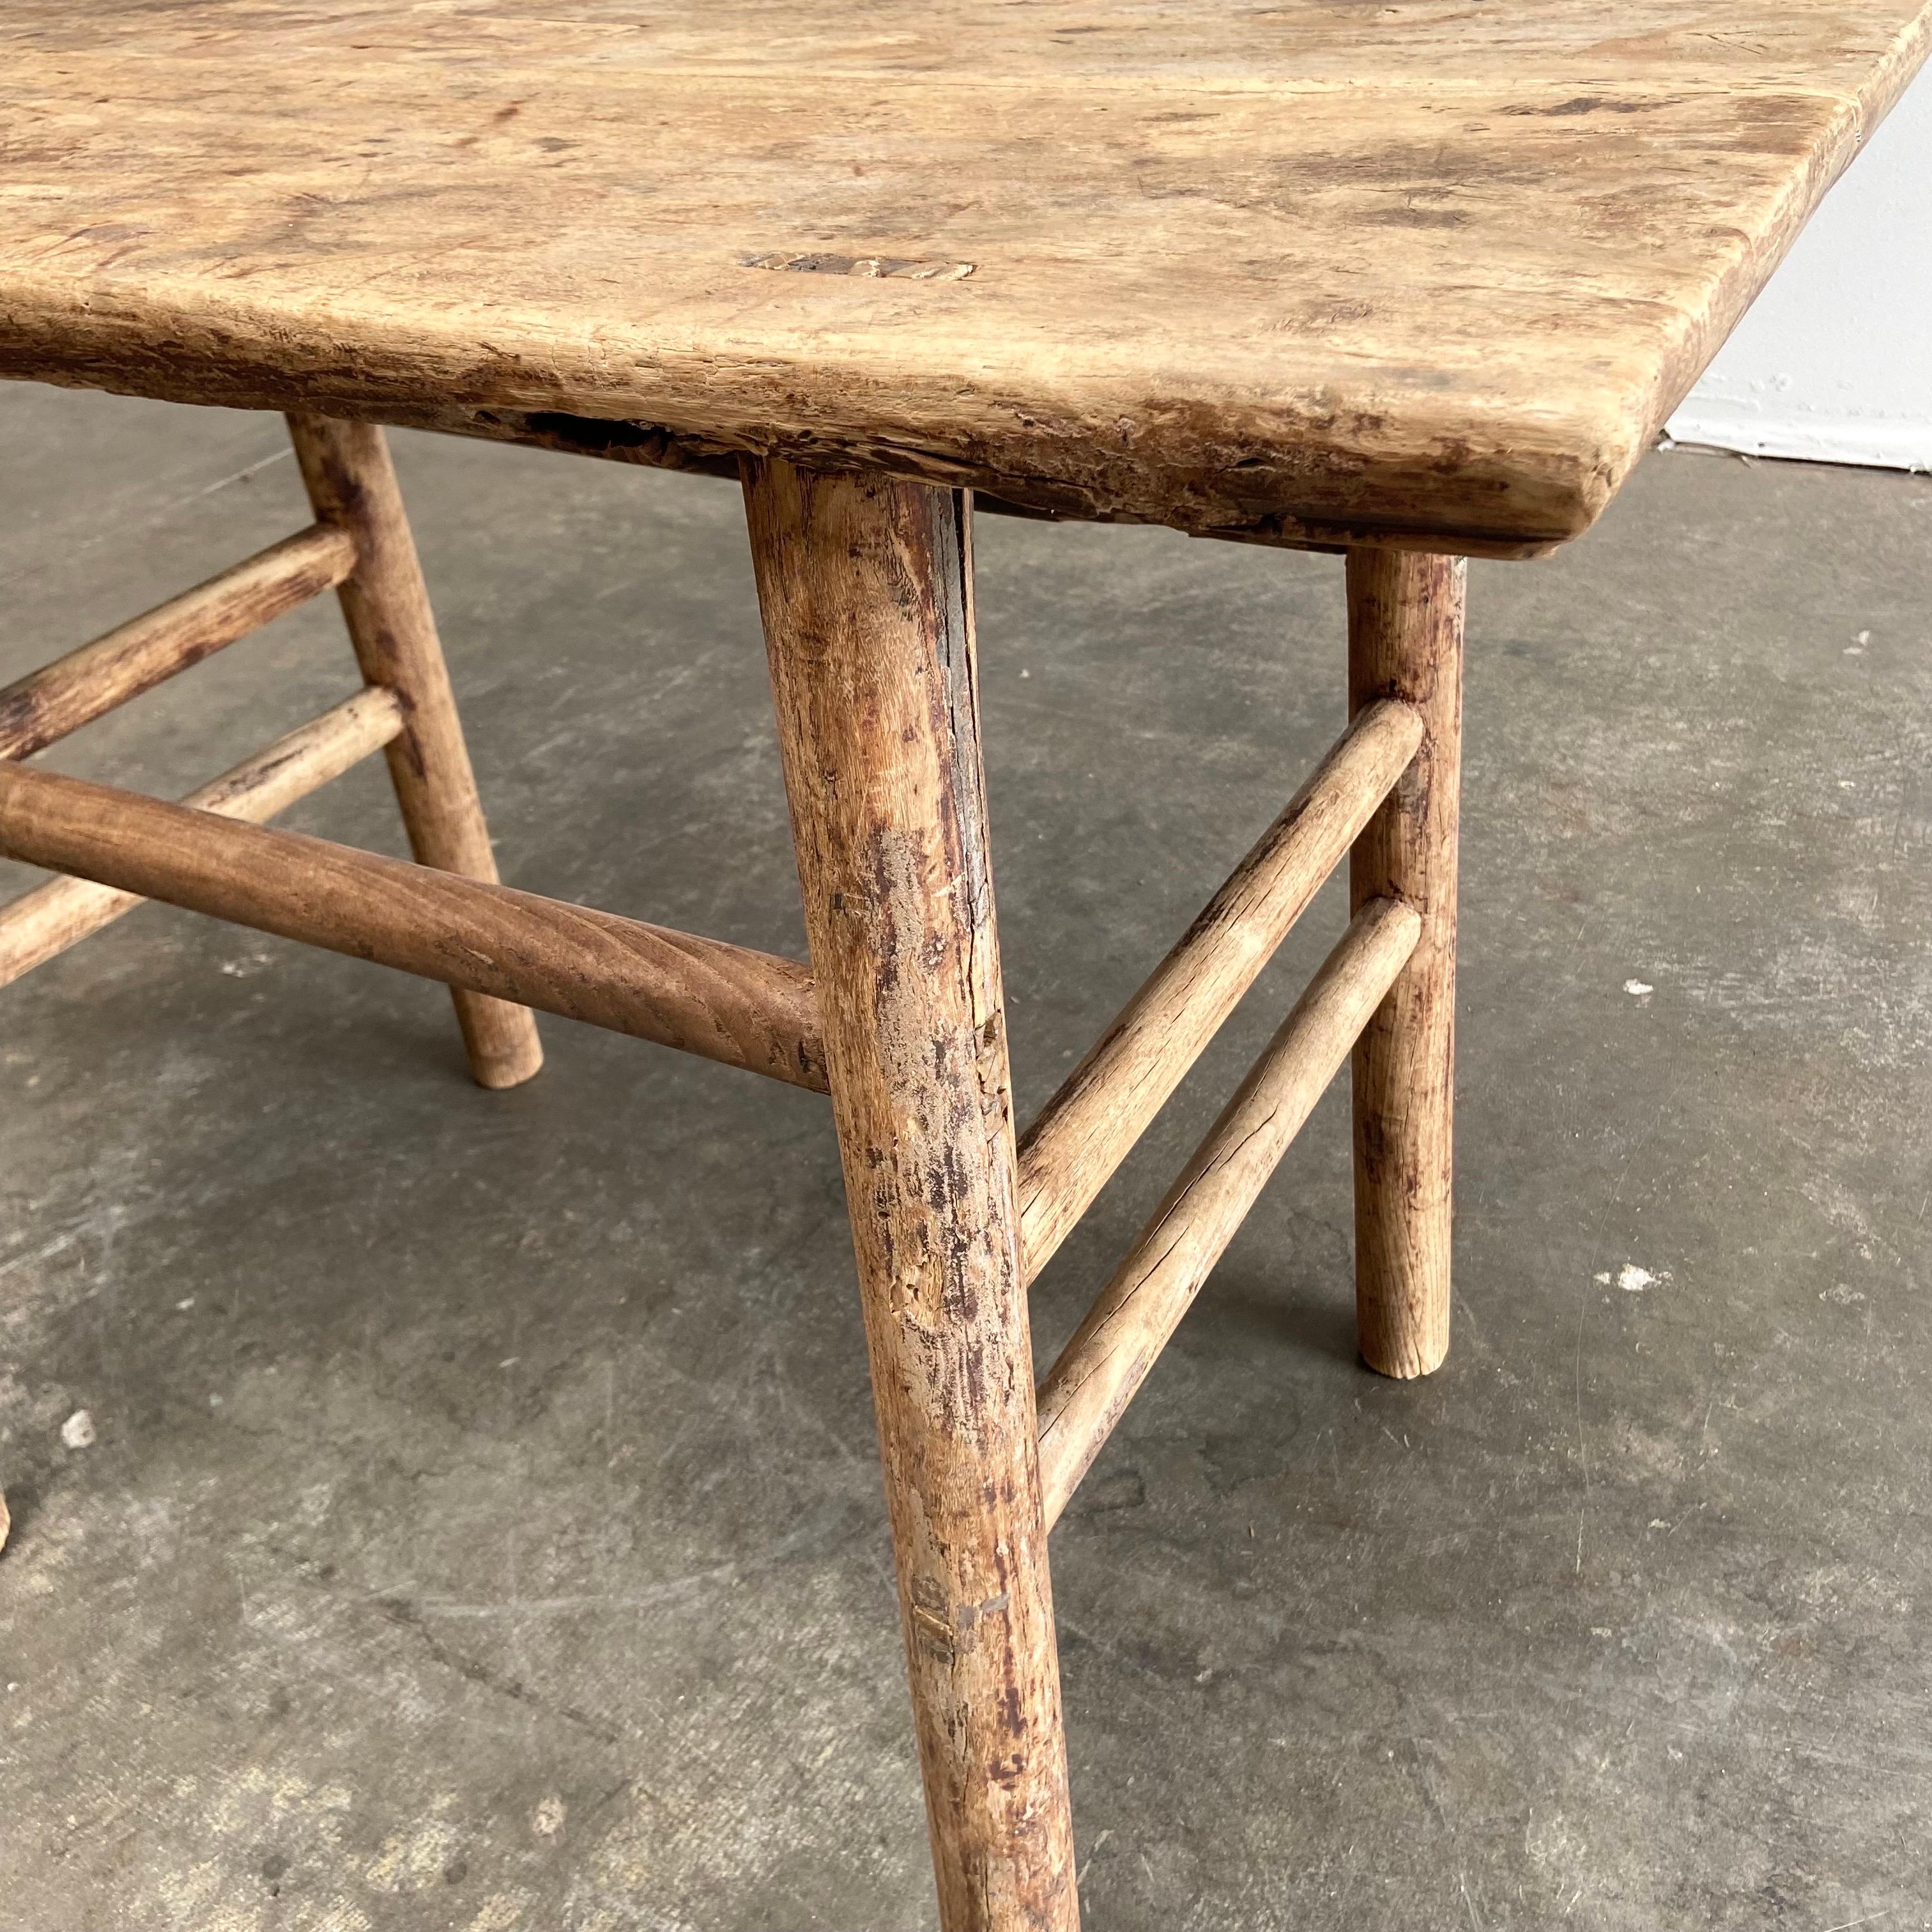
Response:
[0,0,1932,1932]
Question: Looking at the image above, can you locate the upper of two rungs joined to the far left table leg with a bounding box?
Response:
[0,524,355,757]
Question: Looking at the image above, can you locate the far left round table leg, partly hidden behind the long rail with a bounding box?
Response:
[288,415,543,1088]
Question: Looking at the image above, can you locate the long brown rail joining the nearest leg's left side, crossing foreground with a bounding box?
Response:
[0,763,825,1092]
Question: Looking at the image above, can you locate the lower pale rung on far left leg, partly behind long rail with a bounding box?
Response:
[0,684,402,985]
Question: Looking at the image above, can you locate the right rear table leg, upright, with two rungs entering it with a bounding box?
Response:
[1349,551,1466,1376]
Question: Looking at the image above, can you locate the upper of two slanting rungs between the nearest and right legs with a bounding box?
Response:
[1020,700,1422,1281]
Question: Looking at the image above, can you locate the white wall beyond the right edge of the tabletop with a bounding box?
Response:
[1669,68,1932,470]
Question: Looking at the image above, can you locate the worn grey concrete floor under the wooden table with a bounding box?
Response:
[0,388,1932,1932]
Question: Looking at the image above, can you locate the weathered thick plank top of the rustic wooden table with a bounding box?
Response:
[0,0,1932,555]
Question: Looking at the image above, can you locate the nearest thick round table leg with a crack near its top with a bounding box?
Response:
[746,462,1080,1932]
